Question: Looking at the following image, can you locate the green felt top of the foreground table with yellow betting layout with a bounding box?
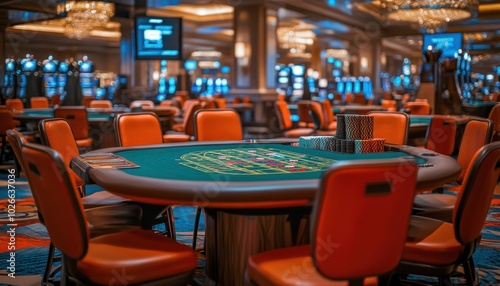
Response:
[116,144,425,182]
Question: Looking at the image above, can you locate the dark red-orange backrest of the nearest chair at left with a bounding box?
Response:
[22,144,89,259]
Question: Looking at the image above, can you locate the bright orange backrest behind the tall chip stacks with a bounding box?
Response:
[368,111,410,144]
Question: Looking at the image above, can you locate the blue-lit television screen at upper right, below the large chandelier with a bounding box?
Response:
[422,33,462,58]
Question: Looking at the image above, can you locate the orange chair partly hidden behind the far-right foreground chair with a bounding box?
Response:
[413,118,493,222]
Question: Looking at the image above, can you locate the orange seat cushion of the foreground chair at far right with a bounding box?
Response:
[401,216,464,265]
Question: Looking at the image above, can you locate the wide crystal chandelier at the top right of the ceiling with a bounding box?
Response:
[380,0,479,33]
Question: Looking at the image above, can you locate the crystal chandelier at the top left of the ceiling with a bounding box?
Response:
[57,1,115,40]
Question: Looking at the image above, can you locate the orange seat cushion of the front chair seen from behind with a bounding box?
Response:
[247,245,377,286]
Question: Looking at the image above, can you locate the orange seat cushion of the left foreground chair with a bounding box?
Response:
[77,230,197,285]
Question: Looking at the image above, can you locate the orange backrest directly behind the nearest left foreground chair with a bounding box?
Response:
[38,118,80,172]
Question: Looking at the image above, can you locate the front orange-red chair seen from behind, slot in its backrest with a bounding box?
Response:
[247,160,417,285]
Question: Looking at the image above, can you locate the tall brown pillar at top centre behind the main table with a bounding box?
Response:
[230,0,278,125]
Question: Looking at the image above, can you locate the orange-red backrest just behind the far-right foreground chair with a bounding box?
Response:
[457,118,493,182]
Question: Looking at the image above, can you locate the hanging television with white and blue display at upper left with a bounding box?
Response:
[135,16,182,60]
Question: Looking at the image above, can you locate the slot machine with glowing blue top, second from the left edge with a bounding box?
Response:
[17,54,42,107]
